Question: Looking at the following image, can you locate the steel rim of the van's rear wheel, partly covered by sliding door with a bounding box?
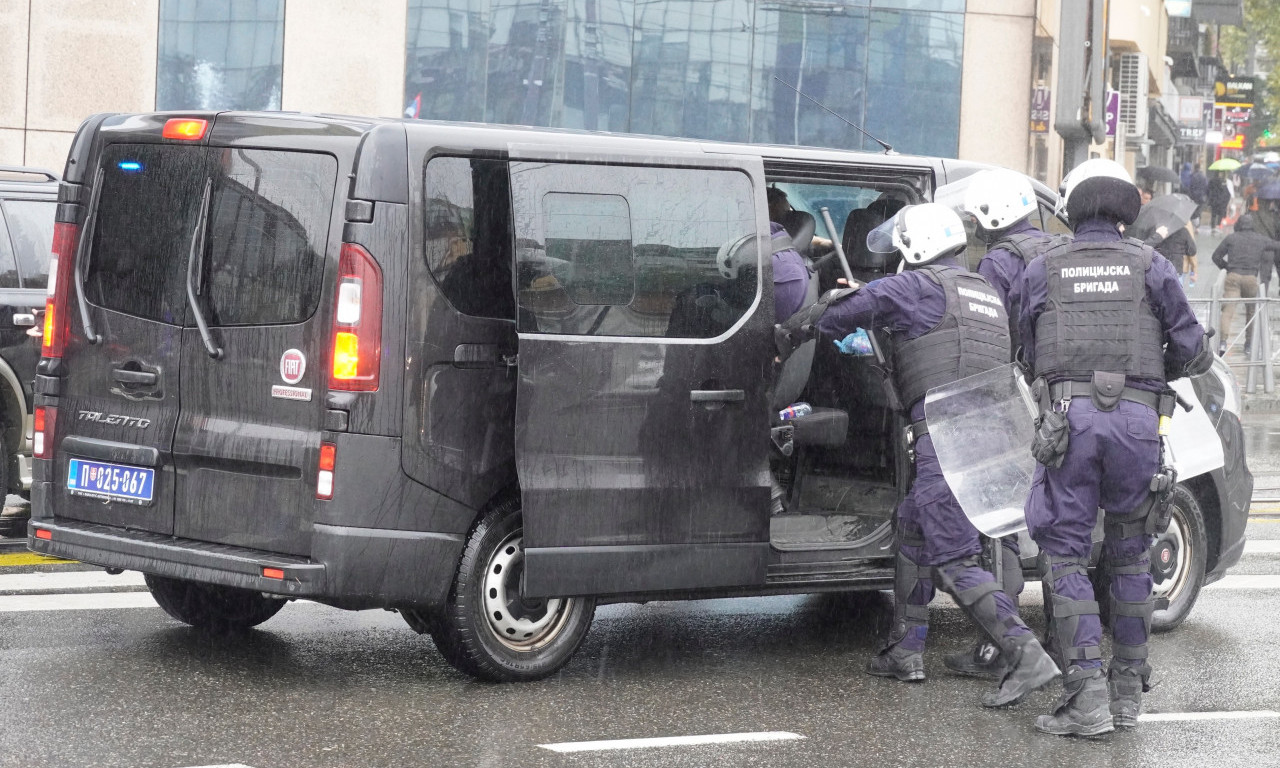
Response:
[480,531,575,653]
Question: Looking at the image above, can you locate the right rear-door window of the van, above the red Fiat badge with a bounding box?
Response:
[205,148,338,325]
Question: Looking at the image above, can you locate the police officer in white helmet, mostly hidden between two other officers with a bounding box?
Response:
[942,168,1061,680]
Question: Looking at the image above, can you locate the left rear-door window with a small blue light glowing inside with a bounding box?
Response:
[84,145,209,325]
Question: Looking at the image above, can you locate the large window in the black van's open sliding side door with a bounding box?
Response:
[511,161,760,338]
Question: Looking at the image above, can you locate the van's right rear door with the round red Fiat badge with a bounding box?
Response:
[173,129,348,554]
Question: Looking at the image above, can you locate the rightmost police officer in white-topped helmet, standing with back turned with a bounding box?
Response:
[1018,159,1212,736]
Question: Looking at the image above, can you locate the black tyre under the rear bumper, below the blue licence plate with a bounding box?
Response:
[146,573,285,635]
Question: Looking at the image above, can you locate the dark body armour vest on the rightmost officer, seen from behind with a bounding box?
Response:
[1036,239,1165,381]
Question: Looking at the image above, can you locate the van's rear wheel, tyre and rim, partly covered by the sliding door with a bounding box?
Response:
[429,500,595,682]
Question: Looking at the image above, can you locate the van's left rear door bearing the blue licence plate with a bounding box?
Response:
[54,138,207,534]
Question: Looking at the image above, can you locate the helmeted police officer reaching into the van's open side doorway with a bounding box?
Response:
[781,204,1059,707]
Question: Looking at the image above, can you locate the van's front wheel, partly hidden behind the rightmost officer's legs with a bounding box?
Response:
[1093,485,1208,632]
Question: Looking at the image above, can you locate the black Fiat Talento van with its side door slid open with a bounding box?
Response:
[29,113,1252,680]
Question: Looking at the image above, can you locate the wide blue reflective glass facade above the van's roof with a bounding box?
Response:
[404,0,965,156]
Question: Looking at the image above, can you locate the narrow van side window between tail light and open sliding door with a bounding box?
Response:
[424,157,516,320]
